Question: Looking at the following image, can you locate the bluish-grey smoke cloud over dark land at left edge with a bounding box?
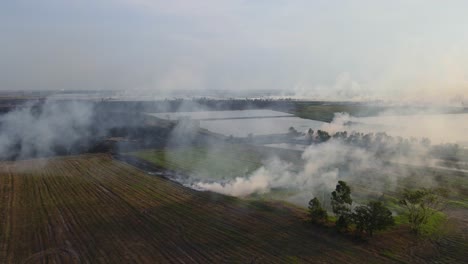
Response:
[0,101,94,159]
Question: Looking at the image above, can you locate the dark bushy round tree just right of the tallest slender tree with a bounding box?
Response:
[351,201,395,236]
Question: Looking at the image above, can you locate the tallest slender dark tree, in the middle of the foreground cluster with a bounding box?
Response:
[331,181,353,230]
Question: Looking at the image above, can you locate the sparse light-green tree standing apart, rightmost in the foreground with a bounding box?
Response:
[400,188,447,233]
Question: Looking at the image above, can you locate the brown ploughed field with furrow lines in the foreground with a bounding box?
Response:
[0,154,466,263]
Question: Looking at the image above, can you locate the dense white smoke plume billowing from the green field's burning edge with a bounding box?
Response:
[195,140,397,202]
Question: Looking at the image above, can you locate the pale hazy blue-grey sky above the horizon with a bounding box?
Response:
[0,0,468,100]
